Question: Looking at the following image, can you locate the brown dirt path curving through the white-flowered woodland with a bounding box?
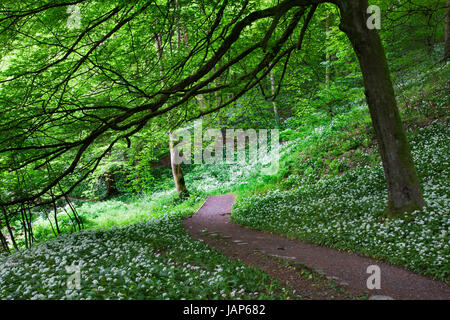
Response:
[183,195,450,300]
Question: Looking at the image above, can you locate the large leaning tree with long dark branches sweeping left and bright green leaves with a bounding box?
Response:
[0,0,424,216]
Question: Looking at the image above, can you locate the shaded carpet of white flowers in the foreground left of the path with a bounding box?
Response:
[0,211,285,299]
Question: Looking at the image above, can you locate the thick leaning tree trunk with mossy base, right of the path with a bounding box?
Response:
[338,0,425,216]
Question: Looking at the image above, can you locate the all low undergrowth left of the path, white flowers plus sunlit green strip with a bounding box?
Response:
[0,185,299,300]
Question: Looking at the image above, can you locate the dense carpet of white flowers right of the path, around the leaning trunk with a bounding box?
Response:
[232,122,450,280]
